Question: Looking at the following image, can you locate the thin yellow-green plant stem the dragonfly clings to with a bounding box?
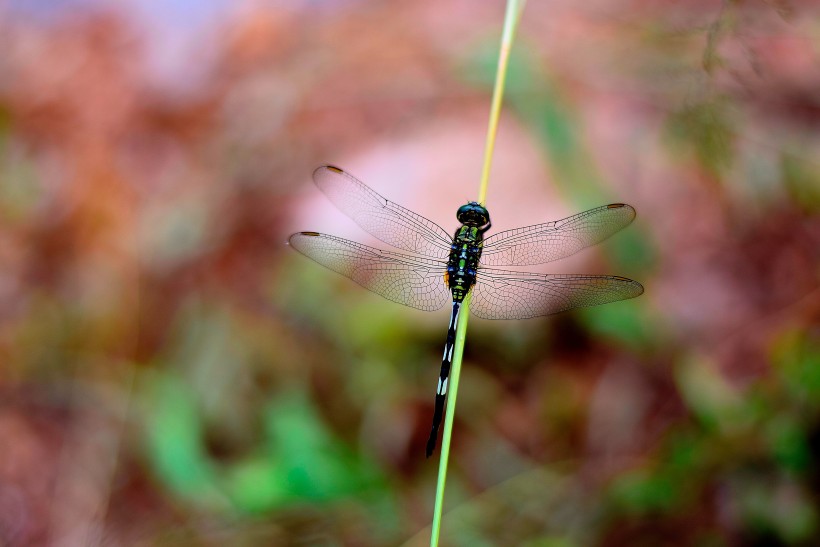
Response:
[430,0,526,547]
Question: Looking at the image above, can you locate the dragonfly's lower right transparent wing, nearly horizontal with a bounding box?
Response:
[470,268,643,319]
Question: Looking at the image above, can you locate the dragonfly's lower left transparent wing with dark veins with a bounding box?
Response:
[288,232,450,311]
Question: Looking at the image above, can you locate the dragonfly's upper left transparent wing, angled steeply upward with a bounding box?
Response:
[313,165,452,258]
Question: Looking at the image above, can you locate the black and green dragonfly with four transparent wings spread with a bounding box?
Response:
[288,165,643,458]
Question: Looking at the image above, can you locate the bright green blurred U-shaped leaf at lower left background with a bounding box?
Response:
[145,374,391,513]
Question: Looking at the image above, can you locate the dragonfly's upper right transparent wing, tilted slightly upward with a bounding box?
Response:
[481,203,635,266]
